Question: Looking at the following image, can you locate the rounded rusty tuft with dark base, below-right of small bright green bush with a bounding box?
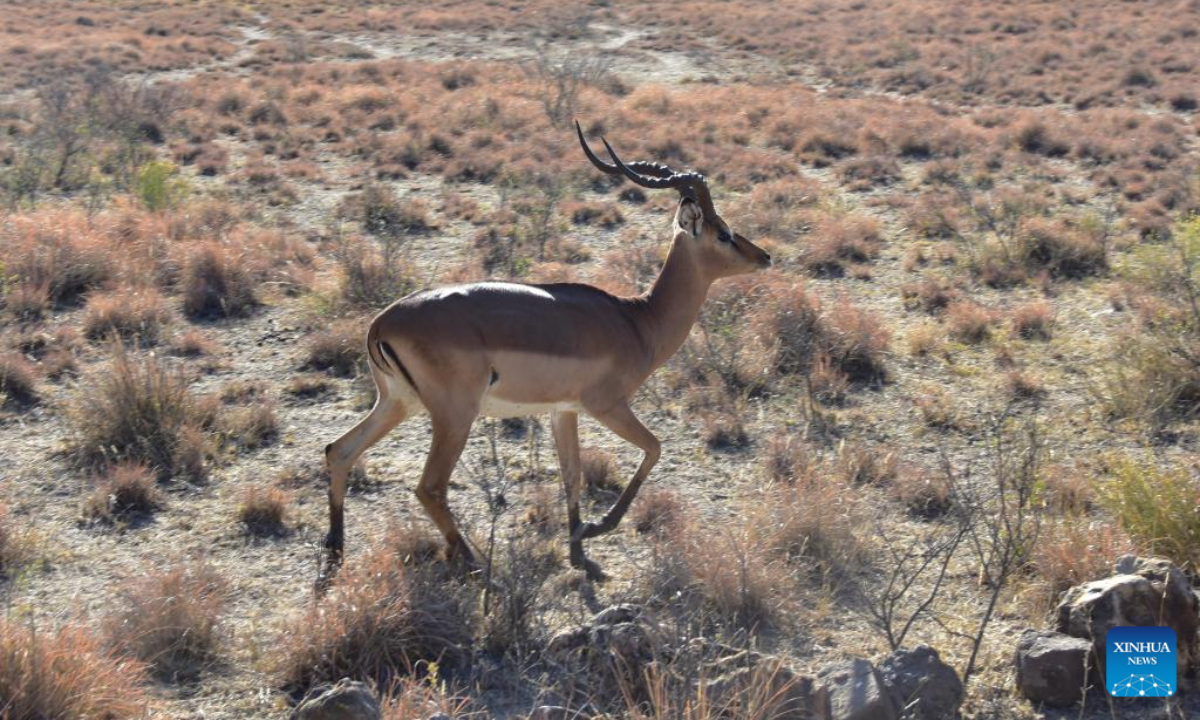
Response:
[181,242,258,320]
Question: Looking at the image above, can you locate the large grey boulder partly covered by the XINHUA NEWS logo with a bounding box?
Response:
[1056,556,1200,676]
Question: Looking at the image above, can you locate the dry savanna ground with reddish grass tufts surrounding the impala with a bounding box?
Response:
[0,0,1200,719]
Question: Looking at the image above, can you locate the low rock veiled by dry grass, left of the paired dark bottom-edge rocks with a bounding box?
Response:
[704,650,824,720]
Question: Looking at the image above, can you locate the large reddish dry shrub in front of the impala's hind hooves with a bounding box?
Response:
[276,547,470,695]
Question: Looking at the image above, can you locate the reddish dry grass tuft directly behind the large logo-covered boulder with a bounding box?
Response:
[1030,517,1136,598]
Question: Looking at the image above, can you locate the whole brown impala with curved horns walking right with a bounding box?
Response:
[325,122,770,580]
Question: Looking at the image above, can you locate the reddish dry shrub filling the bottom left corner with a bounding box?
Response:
[0,617,150,720]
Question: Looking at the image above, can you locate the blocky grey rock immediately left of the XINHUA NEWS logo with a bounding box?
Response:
[1014,630,1099,708]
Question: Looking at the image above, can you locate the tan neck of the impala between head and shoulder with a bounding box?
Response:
[646,240,713,368]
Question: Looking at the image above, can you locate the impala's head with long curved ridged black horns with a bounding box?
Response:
[575,121,770,278]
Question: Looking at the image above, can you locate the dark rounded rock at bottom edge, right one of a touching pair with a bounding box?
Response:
[880,646,964,720]
